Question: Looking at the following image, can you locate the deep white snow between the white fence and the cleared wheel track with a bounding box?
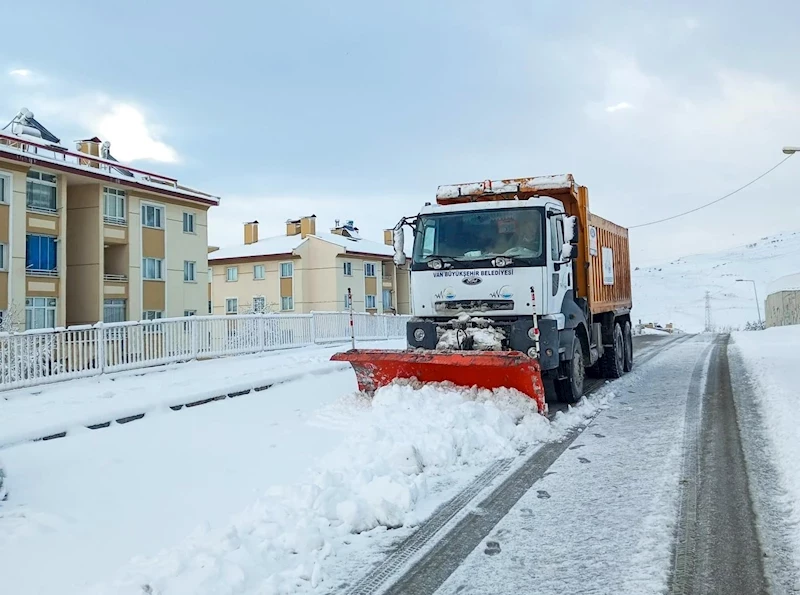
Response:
[0,342,594,595]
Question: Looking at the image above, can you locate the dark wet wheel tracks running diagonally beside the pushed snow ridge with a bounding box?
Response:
[346,335,691,595]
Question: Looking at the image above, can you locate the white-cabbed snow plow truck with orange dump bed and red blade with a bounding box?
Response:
[332,174,633,413]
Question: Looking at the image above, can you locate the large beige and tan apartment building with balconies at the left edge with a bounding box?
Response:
[0,109,219,330]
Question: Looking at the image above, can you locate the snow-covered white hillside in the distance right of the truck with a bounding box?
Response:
[633,232,800,332]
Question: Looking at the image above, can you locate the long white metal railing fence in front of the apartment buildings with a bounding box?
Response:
[0,312,409,391]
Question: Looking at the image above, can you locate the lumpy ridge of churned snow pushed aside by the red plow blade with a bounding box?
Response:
[93,383,592,595]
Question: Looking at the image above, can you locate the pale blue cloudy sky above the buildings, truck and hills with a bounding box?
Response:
[0,0,800,264]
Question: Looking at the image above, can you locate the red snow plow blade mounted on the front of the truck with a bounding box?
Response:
[331,349,546,413]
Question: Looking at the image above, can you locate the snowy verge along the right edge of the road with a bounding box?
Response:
[733,325,800,567]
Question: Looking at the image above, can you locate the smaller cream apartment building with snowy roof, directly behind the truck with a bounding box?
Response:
[208,215,410,314]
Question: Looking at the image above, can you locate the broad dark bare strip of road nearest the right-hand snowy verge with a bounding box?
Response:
[670,335,769,595]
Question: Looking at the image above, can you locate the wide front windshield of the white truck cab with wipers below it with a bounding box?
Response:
[413,207,544,269]
